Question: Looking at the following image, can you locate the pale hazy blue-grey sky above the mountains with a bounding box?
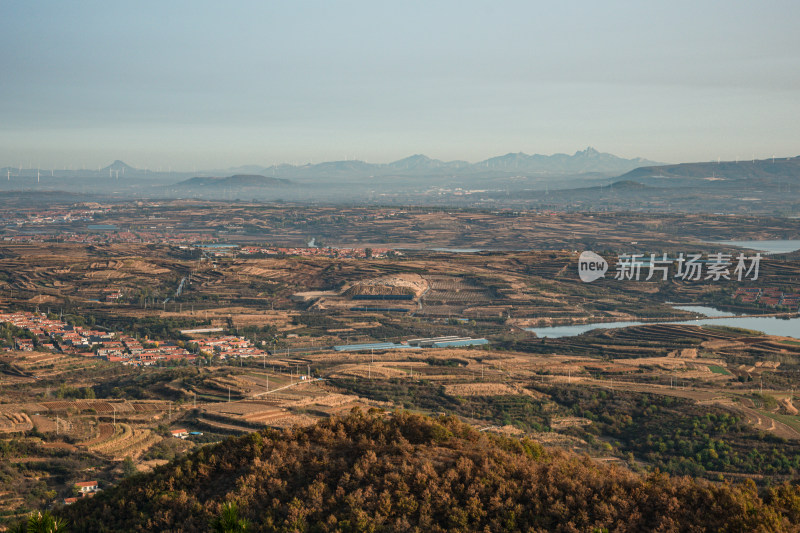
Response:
[0,0,800,170]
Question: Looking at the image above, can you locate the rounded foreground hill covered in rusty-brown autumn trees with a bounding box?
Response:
[57,413,800,532]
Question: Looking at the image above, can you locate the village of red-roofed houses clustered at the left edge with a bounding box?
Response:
[0,312,267,366]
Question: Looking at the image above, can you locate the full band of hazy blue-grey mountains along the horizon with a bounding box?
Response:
[0,151,800,214]
